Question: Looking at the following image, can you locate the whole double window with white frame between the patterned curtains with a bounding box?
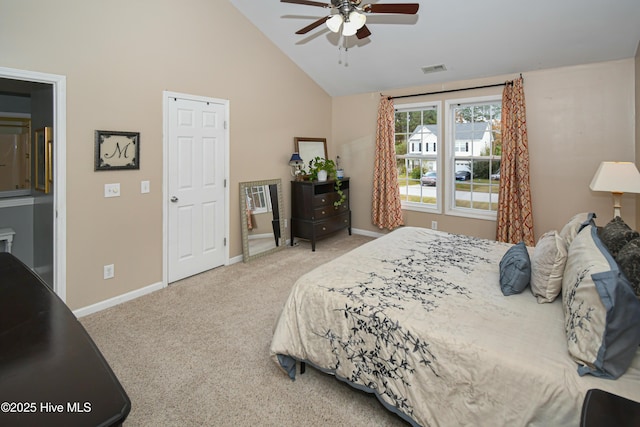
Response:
[395,95,502,219]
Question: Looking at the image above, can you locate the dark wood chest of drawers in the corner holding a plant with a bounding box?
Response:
[291,178,351,251]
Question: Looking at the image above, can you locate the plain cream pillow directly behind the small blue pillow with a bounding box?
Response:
[531,230,567,304]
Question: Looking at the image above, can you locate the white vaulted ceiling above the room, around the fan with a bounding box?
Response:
[229,0,640,96]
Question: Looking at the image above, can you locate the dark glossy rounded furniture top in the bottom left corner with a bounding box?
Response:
[0,252,131,426]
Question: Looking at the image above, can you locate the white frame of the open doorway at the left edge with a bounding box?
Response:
[0,67,67,303]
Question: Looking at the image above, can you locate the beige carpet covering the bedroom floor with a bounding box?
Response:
[80,233,407,427]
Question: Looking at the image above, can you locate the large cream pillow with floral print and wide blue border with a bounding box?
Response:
[562,225,640,378]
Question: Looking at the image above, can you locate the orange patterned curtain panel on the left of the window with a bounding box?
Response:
[373,96,403,230]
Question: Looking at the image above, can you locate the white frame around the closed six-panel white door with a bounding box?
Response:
[162,90,230,288]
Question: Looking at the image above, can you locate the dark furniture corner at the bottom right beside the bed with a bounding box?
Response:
[580,389,640,427]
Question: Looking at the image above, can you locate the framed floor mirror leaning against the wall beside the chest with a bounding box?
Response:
[240,179,285,262]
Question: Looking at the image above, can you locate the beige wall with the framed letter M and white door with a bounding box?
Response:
[0,0,331,309]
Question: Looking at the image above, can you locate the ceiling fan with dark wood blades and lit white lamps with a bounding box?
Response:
[280,0,420,39]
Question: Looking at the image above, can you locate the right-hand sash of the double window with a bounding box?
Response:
[447,99,502,217]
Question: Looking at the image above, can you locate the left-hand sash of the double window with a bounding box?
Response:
[395,104,440,210]
